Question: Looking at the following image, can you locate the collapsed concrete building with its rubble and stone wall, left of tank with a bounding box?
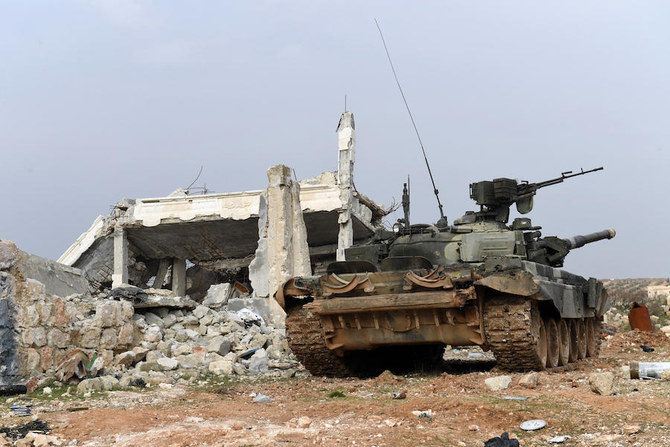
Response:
[0,112,386,388]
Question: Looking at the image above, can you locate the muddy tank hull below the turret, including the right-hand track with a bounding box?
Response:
[279,258,608,375]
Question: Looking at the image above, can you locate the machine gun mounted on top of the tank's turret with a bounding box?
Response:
[470,166,603,223]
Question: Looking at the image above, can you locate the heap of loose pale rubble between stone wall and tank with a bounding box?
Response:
[59,284,299,393]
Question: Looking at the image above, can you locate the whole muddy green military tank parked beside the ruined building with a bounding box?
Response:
[275,168,615,376]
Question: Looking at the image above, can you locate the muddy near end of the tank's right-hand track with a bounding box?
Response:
[483,295,547,371]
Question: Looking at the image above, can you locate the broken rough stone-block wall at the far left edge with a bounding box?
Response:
[0,241,135,384]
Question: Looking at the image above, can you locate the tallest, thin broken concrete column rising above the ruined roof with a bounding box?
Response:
[337,112,356,261]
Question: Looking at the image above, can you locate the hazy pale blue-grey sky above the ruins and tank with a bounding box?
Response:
[0,0,670,277]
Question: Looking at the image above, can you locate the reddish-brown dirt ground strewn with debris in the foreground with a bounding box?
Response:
[0,332,670,447]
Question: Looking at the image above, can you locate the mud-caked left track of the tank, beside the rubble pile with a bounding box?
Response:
[286,307,353,377]
